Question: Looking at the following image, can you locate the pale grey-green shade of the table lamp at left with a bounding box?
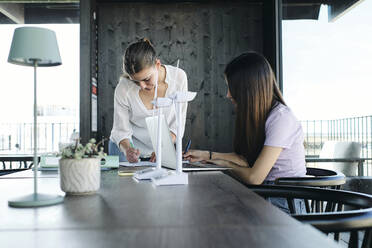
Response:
[8,27,62,67]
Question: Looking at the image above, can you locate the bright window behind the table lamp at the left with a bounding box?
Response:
[0,3,80,154]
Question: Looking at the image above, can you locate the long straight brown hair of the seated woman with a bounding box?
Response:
[225,52,286,166]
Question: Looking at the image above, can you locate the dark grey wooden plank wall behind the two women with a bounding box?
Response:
[98,2,263,151]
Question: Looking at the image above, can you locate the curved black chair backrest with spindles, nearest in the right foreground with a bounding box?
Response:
[247,185,372,248]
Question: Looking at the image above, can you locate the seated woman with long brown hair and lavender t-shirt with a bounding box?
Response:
[184,52,306,211]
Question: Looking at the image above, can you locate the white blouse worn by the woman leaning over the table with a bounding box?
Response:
[110,65,188,157]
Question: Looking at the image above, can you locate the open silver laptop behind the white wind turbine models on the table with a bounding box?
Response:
[146,115,231,171]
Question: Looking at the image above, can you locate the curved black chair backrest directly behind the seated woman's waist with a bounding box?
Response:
[275,167,346,189]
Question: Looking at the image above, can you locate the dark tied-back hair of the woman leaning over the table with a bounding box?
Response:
[123,38,156,75]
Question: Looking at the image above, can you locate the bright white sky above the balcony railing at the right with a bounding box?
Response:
[282,1,372,120]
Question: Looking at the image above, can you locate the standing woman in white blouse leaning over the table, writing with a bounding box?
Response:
[109,39,188,163]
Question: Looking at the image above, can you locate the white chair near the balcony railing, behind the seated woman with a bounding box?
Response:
[317,141,362,176]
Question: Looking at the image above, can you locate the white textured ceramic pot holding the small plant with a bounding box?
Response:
[59,158,101,195]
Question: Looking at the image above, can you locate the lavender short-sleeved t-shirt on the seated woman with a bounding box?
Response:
[264,103,306,181]
